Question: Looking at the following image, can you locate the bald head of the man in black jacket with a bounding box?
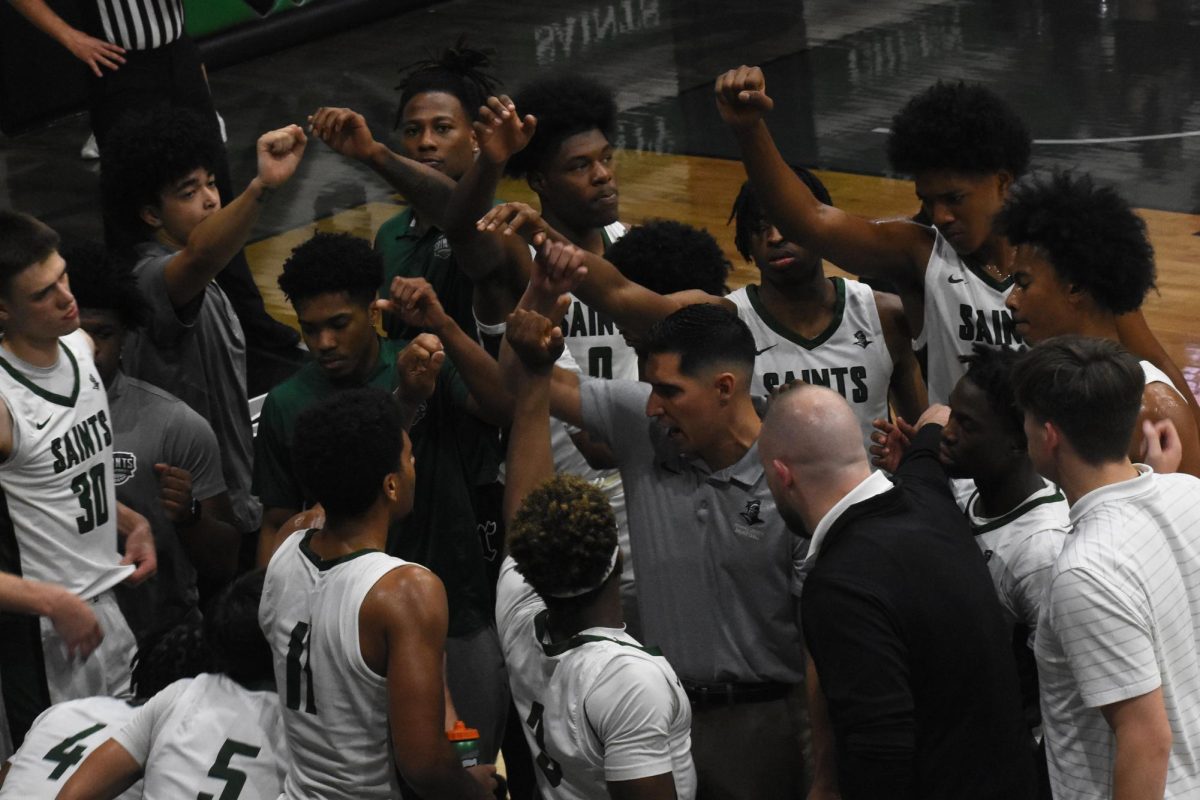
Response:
[758,384,871,535]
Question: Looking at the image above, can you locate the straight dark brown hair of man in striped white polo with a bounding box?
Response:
[1013,336,1146,465]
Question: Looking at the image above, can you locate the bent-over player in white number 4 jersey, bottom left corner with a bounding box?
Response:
[0,606,211,800]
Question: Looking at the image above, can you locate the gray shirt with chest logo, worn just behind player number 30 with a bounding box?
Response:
[108,372,226,639]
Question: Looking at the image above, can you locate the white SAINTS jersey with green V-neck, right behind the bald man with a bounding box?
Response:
[728,278,894,446]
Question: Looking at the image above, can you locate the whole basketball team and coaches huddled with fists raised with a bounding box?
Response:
[0,35,1200,800]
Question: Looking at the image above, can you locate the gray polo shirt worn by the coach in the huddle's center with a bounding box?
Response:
[580,379,805,684]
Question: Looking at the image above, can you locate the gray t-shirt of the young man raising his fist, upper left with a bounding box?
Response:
[122,242,263,533]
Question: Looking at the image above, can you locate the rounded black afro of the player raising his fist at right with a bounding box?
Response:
[888,80,1031,178]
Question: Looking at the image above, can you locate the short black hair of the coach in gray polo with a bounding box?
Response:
[643,303,757,377]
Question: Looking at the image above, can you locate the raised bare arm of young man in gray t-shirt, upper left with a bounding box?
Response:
[164,125,307,308]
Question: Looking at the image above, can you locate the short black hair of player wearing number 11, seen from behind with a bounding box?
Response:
[292,387,404,517]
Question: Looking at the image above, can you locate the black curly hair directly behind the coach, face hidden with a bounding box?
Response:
[605,219,730,295]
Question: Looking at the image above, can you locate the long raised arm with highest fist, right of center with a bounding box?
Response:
[715,66,934,291]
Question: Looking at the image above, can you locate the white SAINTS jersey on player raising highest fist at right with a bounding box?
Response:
[913,229,1022,404]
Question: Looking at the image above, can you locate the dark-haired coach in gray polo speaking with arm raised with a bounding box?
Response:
[540,303,805,799]
